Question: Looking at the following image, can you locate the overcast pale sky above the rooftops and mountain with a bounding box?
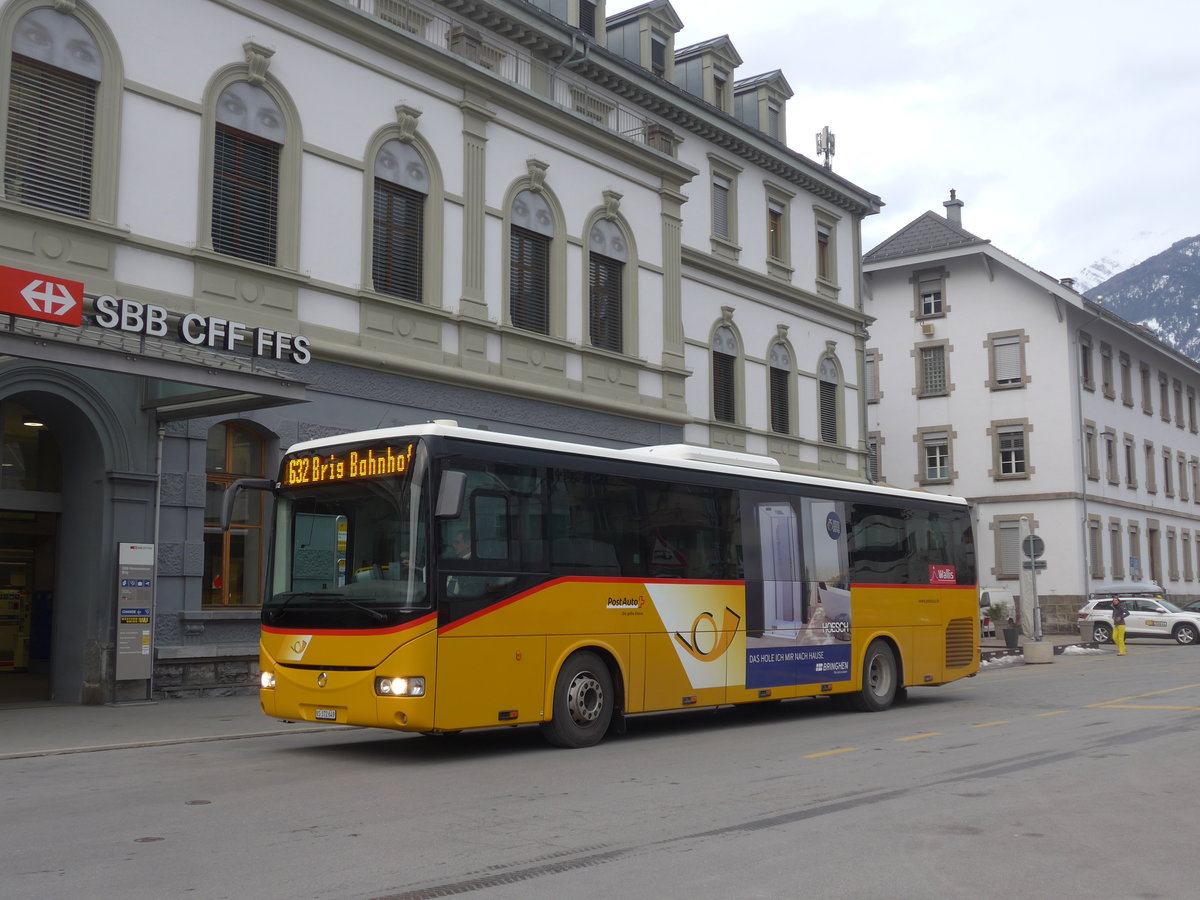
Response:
[607,0,1200,285]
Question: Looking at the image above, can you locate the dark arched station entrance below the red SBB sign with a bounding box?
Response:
[0,374,119,703]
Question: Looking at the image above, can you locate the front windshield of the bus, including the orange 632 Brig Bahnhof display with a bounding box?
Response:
[263,444,432,630]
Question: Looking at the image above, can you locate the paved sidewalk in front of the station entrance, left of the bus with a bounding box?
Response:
[0,692,346,760]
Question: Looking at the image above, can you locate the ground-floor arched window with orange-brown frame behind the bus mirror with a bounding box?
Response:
[202,422,266,606]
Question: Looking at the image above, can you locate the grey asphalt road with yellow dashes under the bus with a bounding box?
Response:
[0,642,1200,900]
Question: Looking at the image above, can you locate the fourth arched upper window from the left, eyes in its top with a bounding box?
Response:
[509,191,554,335]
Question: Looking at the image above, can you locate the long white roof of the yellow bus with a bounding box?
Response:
[287,420,967,506]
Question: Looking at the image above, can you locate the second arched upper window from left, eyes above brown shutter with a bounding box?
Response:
[212,82,284,265]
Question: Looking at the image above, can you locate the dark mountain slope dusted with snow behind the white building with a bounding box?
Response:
[1085,235,1200,360]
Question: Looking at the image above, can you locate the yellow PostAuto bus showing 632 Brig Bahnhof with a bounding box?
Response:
[226,422,979,748]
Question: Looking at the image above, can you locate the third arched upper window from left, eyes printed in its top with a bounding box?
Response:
[371,140,430,301]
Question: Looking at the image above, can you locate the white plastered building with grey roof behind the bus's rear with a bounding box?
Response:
[863,192,1200,631]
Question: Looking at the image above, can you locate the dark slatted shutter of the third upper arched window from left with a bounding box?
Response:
[371,178,425,301]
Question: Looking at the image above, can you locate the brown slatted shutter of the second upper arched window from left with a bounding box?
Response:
[212,128,280,265]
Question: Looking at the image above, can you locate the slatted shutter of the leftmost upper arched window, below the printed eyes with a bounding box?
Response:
[4,54,98,218]
